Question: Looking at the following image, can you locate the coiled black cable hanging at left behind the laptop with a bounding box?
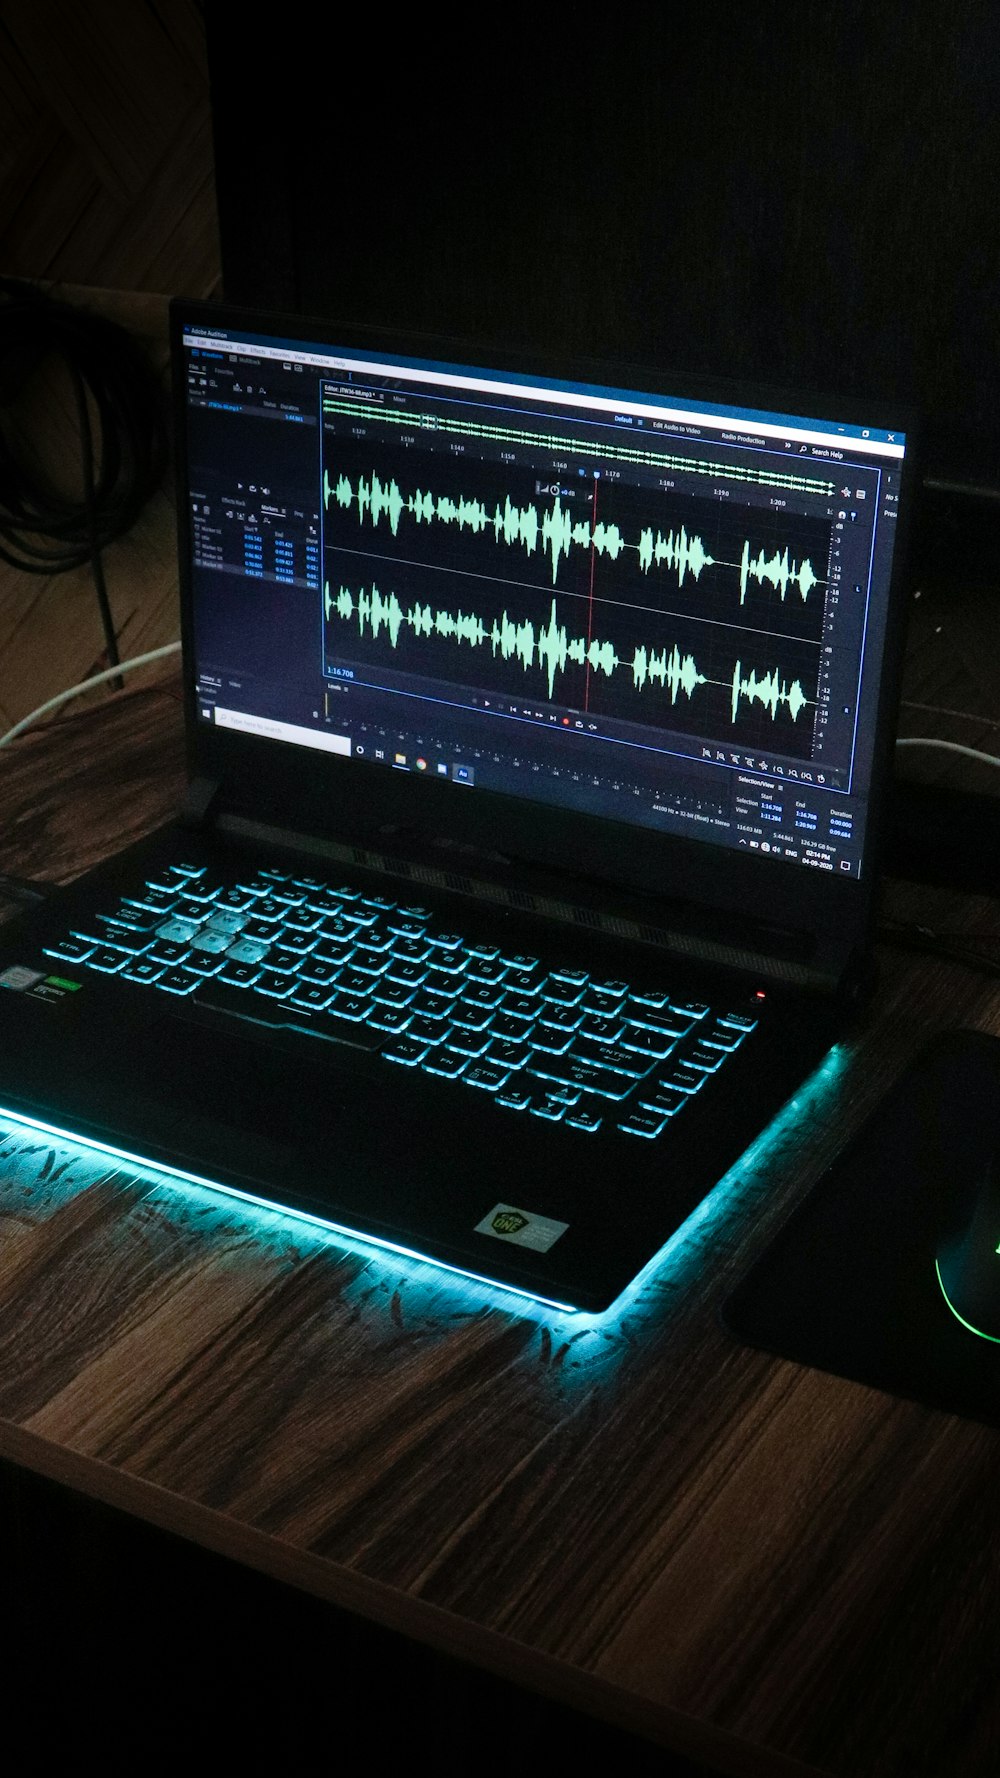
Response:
[0,277,167,685]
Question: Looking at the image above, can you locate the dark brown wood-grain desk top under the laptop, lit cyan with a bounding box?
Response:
[0,683,1000,1778]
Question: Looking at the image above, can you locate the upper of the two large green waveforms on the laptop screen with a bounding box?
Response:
[324,473,820,605]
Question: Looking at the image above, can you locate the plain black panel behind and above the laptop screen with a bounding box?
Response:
[206,0,1000,489]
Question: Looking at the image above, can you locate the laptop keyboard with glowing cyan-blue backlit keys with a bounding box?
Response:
[46,864,756,1140]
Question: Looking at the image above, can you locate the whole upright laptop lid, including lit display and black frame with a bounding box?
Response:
[173,302,911,987]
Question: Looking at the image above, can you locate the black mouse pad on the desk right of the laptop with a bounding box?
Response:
[722,1031,1000,1426]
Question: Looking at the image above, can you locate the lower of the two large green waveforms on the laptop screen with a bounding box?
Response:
[324,581,810,722]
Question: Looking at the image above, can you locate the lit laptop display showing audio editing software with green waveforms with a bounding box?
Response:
[181,322,906,877]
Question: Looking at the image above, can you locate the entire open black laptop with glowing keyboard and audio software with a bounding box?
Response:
[0,304,909,1310]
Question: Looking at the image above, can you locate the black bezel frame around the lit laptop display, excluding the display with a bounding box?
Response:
[171,300,915,958]
